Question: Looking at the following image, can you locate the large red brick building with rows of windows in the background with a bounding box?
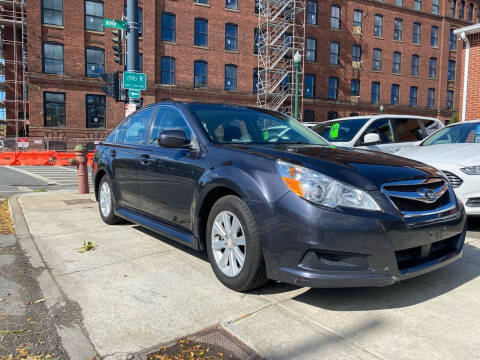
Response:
[6,0,479,143]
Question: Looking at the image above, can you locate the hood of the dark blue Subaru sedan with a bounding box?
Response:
[223,144,441,190]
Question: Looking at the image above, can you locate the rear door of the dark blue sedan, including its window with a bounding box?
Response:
[109,107,155,211]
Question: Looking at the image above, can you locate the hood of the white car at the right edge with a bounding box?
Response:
[396,143,480,166]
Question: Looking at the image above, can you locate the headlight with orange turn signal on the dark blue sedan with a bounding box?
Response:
[277,160,381,211]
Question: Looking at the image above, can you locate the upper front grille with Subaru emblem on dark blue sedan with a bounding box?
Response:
[382,178,455,216]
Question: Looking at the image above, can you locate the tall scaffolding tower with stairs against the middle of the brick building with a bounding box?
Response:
[256,0,306,120]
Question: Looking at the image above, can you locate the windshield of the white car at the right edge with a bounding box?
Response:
[422,122,480,146]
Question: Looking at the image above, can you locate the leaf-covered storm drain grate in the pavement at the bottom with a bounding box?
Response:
[137,327,262,360]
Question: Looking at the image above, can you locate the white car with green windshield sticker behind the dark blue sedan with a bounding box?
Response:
[313,115,443,154]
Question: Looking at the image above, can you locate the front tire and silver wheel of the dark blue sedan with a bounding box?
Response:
[206,195,267,291]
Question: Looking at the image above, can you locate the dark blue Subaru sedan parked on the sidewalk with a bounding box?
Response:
[93,102,466,291]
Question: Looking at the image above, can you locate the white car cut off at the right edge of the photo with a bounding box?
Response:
[395,120,480,216]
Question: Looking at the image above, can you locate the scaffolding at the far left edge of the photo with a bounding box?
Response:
[0,0,28,143]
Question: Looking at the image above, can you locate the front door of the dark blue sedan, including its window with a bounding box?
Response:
[139,106,203,231]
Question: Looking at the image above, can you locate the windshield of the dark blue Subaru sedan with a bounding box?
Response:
[190,104,328,145]
